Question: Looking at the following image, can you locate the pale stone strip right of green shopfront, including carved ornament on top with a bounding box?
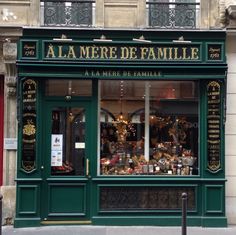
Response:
[224,0,236,224]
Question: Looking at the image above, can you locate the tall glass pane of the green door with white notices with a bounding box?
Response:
[51,107,85,175]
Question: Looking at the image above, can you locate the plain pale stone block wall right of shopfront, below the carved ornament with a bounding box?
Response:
[225,34,236,224]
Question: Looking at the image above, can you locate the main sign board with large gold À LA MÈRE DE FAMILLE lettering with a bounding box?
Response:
[44,42,200,61]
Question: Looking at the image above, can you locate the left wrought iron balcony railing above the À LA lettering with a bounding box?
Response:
[40,0,95,27]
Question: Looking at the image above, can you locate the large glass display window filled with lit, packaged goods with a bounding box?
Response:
[99,80,199,176]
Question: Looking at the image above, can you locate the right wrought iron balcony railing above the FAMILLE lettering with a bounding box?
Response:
[146,0,200,29]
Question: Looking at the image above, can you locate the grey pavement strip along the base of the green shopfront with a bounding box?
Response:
[2,225,236,235]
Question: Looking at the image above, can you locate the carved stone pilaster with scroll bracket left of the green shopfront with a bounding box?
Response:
[1,42,17,224]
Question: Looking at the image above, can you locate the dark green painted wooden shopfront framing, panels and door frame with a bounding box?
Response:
[14,28,227,227]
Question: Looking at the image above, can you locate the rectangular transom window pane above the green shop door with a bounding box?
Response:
[45,79,92,96]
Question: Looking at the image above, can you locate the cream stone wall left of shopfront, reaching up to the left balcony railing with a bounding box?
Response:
[0,0,37,224]
